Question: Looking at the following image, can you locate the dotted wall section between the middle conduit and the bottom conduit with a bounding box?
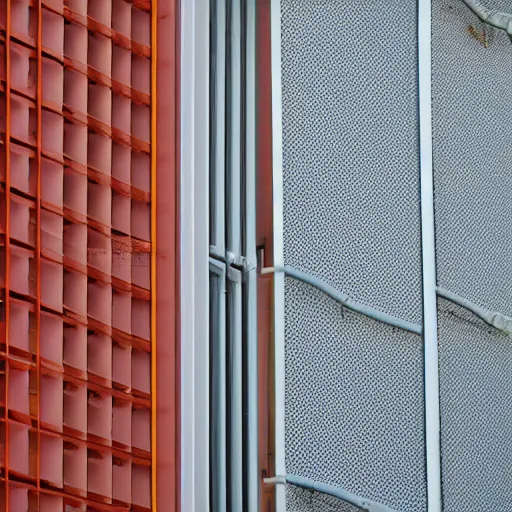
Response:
[285,277,426,512]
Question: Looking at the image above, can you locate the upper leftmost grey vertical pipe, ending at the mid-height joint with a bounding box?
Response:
[213,0,226,255]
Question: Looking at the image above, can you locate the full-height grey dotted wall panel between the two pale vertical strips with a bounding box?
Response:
[281,0,426,512]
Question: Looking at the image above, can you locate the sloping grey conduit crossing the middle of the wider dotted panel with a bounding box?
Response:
[261,265,422,334]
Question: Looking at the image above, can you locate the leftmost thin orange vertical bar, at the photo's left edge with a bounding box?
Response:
[5,0,11,512]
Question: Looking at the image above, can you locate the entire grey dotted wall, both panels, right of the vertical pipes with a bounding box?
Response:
[281,0,512,512]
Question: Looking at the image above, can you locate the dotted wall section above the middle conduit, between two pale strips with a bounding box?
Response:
[281,0,422,323]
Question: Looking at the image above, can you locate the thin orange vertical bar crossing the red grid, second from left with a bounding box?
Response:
[36,0,43,504]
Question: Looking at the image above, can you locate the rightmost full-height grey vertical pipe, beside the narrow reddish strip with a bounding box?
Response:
[244,0,260,512]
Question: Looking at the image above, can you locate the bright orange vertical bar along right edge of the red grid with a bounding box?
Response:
[150,0,158,512]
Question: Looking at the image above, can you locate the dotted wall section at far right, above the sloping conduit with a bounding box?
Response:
[432,0,512,315]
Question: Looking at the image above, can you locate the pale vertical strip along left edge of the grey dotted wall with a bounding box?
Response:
[270,0,286,512]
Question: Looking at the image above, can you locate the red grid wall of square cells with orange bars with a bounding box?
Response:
[0,0,151,512]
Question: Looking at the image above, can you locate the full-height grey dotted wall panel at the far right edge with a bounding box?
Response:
[432,0,512,512]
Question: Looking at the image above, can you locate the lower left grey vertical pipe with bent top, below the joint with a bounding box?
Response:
[210,259,227,512]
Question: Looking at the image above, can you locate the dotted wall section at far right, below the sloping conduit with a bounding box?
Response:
[438,299,512,512]
